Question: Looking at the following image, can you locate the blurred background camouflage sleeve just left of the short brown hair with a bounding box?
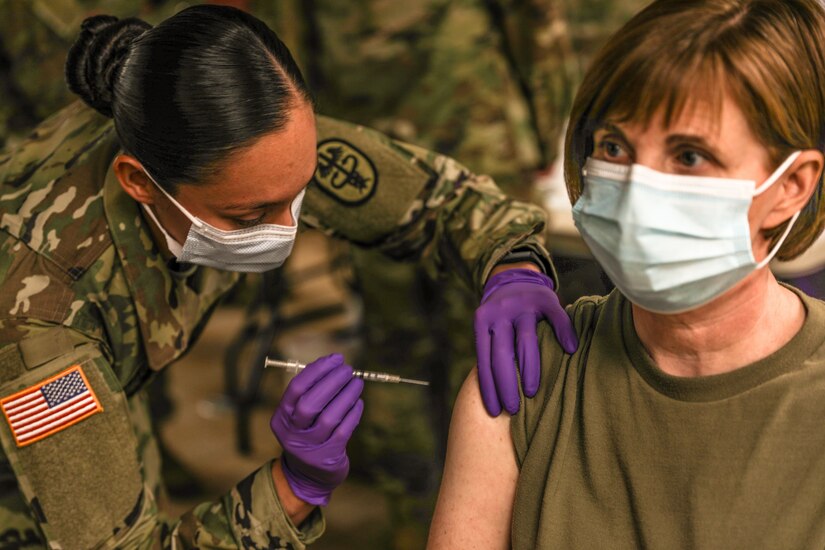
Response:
[486,0,580,167]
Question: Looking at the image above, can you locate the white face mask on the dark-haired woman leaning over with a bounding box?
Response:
[143,169,306,273]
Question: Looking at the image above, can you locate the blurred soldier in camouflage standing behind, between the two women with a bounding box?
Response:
[250,0,578,549]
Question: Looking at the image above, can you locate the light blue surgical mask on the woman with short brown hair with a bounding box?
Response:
[573,151,800,314]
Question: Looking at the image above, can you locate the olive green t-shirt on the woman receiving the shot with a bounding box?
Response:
[511,291,825,549]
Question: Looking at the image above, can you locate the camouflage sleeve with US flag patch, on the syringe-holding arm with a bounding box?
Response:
[0,321,324,549]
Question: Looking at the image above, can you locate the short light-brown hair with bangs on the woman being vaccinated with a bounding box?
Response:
[564,0,825,260]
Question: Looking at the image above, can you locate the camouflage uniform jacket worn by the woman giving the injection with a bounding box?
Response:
[0,103,552,549]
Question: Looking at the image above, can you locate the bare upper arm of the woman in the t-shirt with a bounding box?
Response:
[428,370,518,549]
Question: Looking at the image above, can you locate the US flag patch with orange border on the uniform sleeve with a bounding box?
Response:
[0,365,103,447]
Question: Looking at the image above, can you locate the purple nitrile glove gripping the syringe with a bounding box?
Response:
[269,353,364,505]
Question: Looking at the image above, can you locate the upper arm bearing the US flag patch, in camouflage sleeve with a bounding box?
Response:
[0,329,146,548]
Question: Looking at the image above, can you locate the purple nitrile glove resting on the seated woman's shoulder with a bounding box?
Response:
[474,269,579,416]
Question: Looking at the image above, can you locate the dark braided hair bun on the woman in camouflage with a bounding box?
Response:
[66,15,152,117]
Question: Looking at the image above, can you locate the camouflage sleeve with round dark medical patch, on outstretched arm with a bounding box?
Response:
[301,117,555,292]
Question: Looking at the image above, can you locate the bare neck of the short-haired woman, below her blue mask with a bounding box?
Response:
[632,268,805,376]
